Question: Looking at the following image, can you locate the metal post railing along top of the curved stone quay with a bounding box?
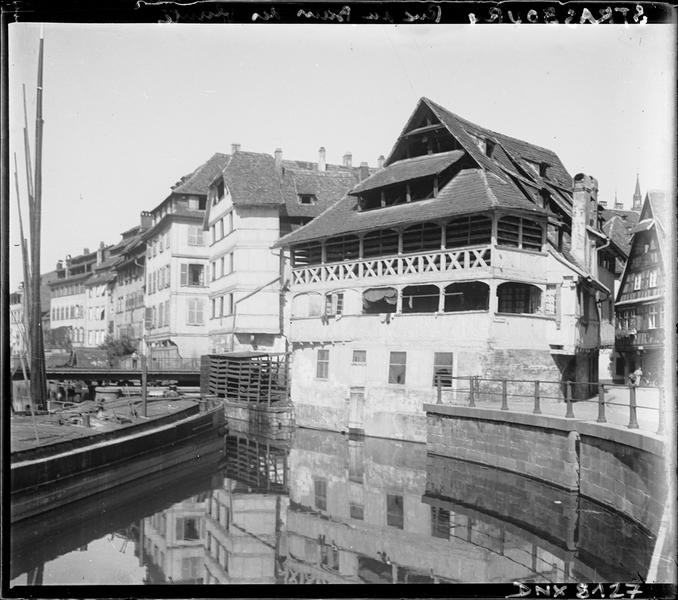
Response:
[435,374,666,435]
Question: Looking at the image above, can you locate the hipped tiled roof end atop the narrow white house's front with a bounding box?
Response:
[224,151,283,206]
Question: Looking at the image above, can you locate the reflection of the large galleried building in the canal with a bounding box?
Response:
[284,430,628,583]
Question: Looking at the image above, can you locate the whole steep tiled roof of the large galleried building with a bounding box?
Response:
[276,98,572,246]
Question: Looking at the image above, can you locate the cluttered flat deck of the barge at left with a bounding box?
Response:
[10,399,195,452]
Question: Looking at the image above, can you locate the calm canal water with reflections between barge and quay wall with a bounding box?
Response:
[10,429,654,585]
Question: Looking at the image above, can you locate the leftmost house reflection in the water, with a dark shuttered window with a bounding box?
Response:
[142,494,207,583]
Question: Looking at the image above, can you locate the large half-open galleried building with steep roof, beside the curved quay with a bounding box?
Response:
[277,98,617,441]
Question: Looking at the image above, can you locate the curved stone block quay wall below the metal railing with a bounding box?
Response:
[424,404,668,535]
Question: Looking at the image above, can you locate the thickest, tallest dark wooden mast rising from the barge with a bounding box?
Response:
[30,30,47,408]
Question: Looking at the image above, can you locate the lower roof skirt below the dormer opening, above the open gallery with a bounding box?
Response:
[276,169,545,246]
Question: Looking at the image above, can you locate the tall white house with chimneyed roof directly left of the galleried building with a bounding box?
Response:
[204,144,370,353]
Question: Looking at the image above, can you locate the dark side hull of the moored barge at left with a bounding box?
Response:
[11,406,224,522]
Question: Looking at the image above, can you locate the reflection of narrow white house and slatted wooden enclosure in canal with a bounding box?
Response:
[204,435,288,583]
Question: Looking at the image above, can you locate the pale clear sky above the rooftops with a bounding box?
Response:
[9,23,676,289]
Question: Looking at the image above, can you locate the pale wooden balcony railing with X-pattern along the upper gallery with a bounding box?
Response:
[292,246,491,285]
